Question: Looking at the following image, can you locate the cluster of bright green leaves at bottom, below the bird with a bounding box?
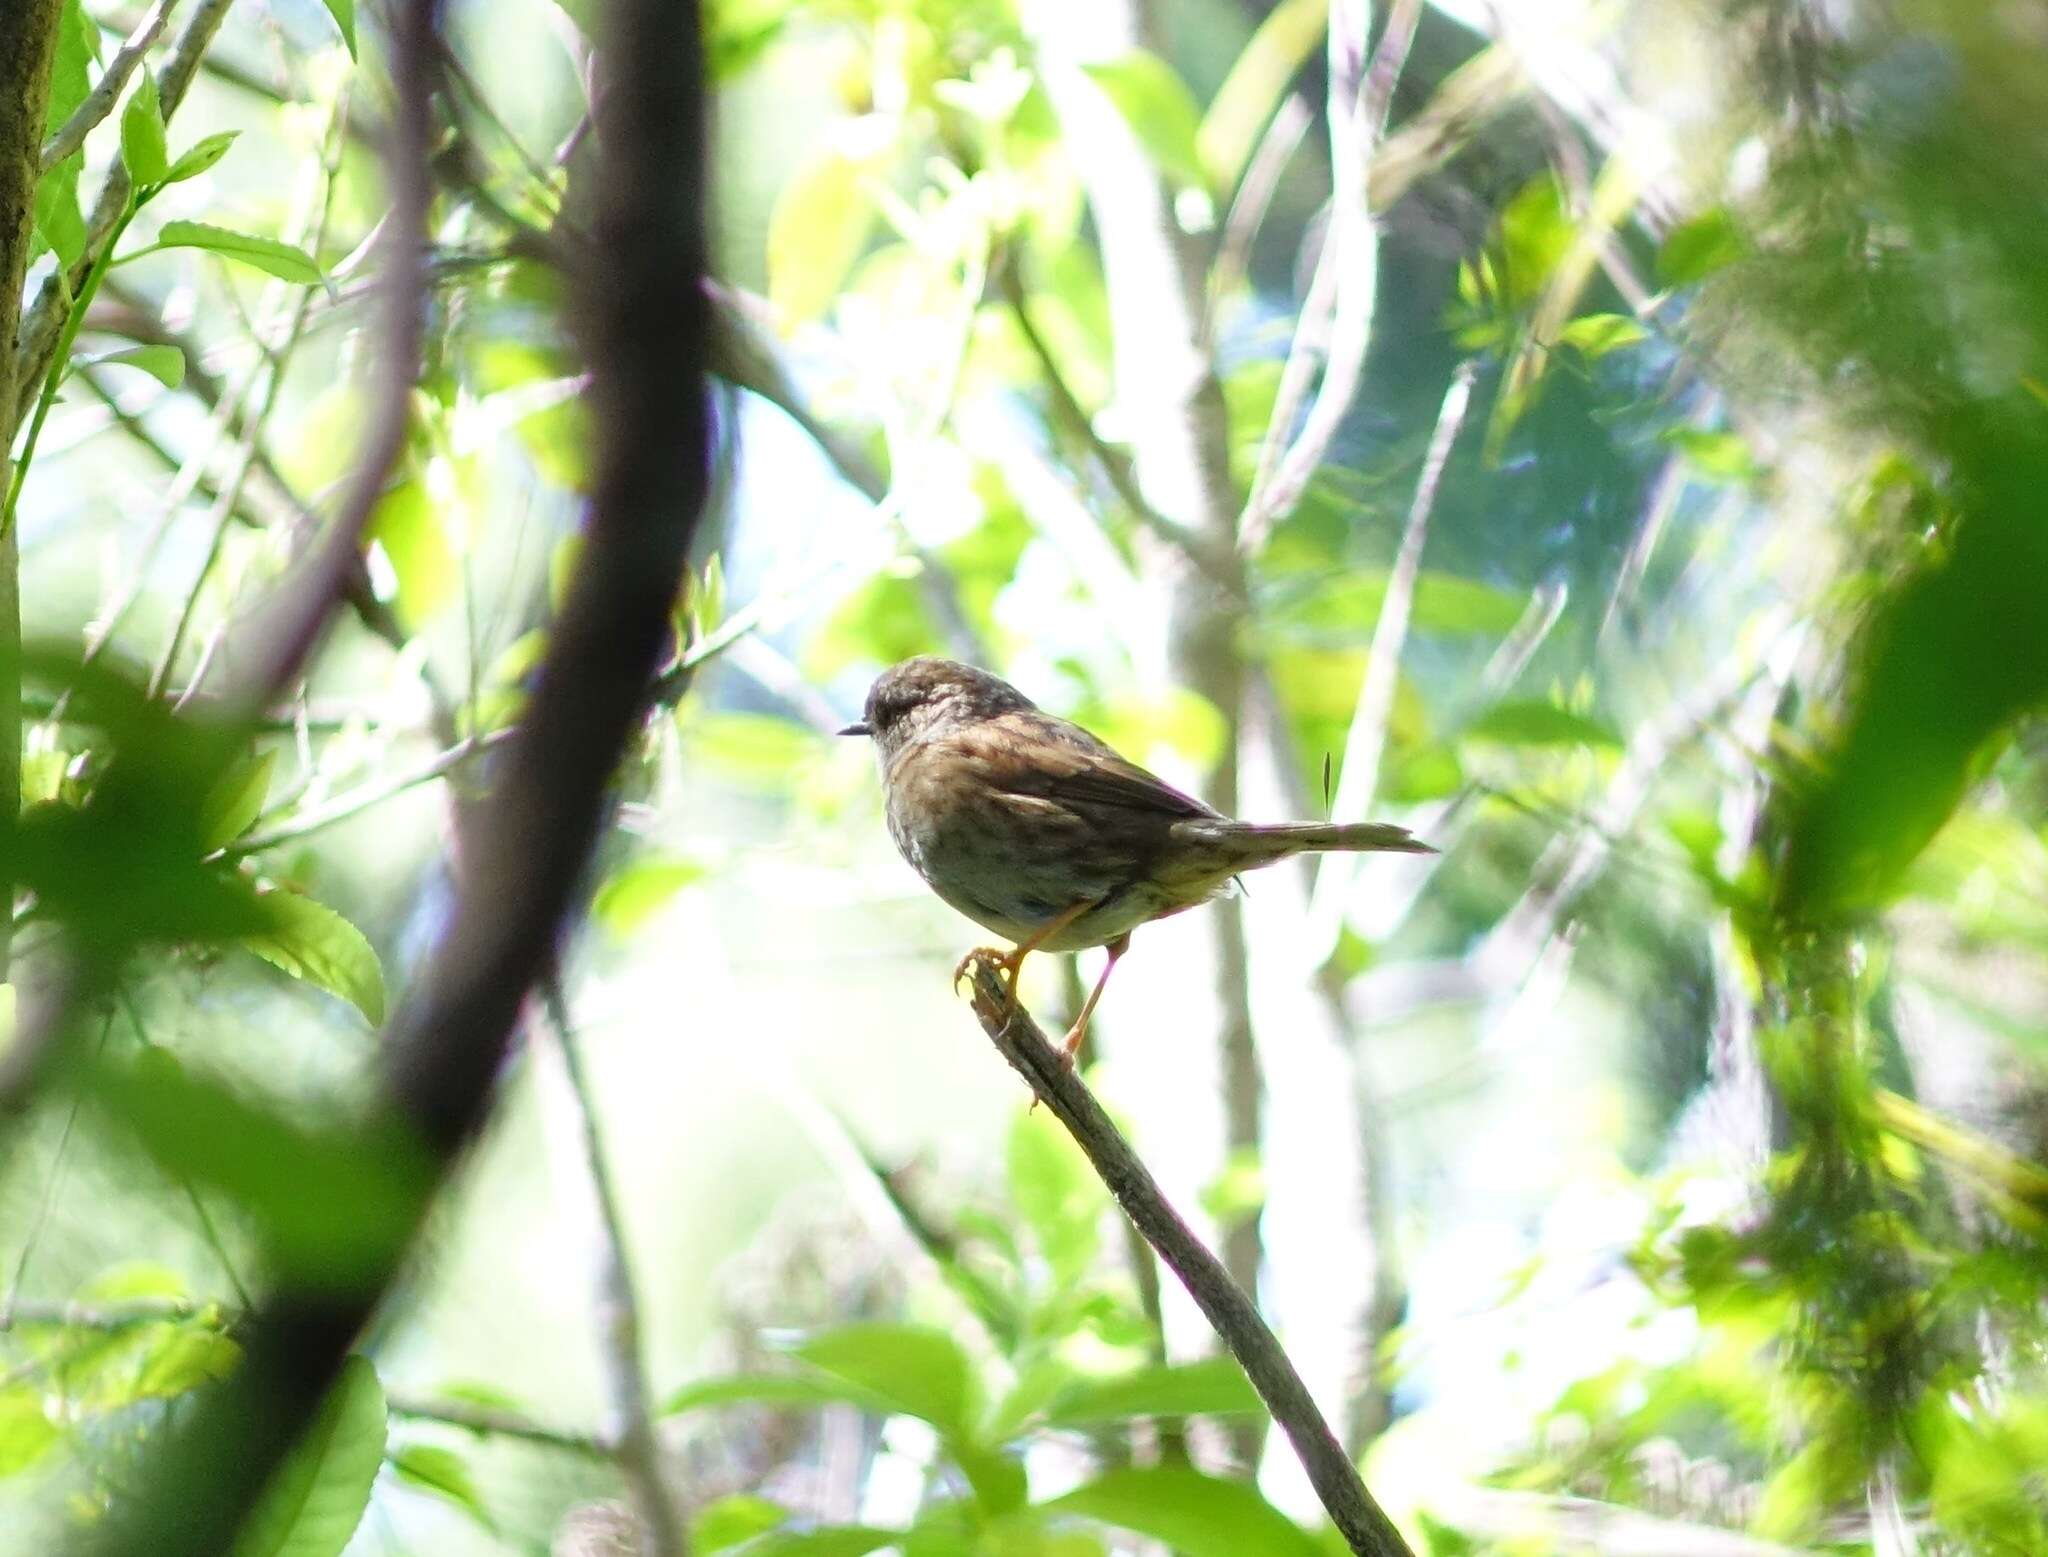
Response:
[664,1112,1329,1557]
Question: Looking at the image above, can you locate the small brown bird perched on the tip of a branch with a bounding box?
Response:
[840,656,1436,1061]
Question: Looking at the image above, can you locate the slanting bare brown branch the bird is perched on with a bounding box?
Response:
[969,957,1413,1557]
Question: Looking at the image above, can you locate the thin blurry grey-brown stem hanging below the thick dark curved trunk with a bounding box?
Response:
[541,973,688,1557]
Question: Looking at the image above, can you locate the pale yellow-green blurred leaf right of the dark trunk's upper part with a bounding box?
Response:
[768,115,895,330]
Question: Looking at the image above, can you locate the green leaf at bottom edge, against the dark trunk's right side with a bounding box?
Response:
[233,1356,387,1557]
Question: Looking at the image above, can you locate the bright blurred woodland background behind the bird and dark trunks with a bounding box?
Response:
[0,0,2048,1557]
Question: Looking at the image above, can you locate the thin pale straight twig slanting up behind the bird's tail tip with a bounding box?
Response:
[1307,363,1477,967]
